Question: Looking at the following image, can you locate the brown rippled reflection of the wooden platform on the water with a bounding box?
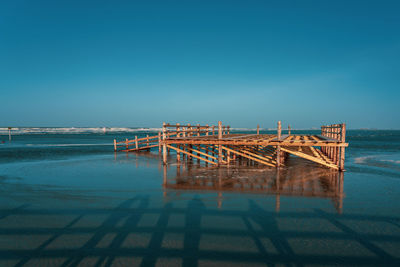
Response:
[163,164,344,213]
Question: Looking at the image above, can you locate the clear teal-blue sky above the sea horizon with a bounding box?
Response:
[0,0,400,129]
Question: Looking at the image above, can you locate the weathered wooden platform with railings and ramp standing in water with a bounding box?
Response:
[114,121,348,171]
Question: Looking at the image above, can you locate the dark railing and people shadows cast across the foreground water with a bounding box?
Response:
[0,195,400,266]
